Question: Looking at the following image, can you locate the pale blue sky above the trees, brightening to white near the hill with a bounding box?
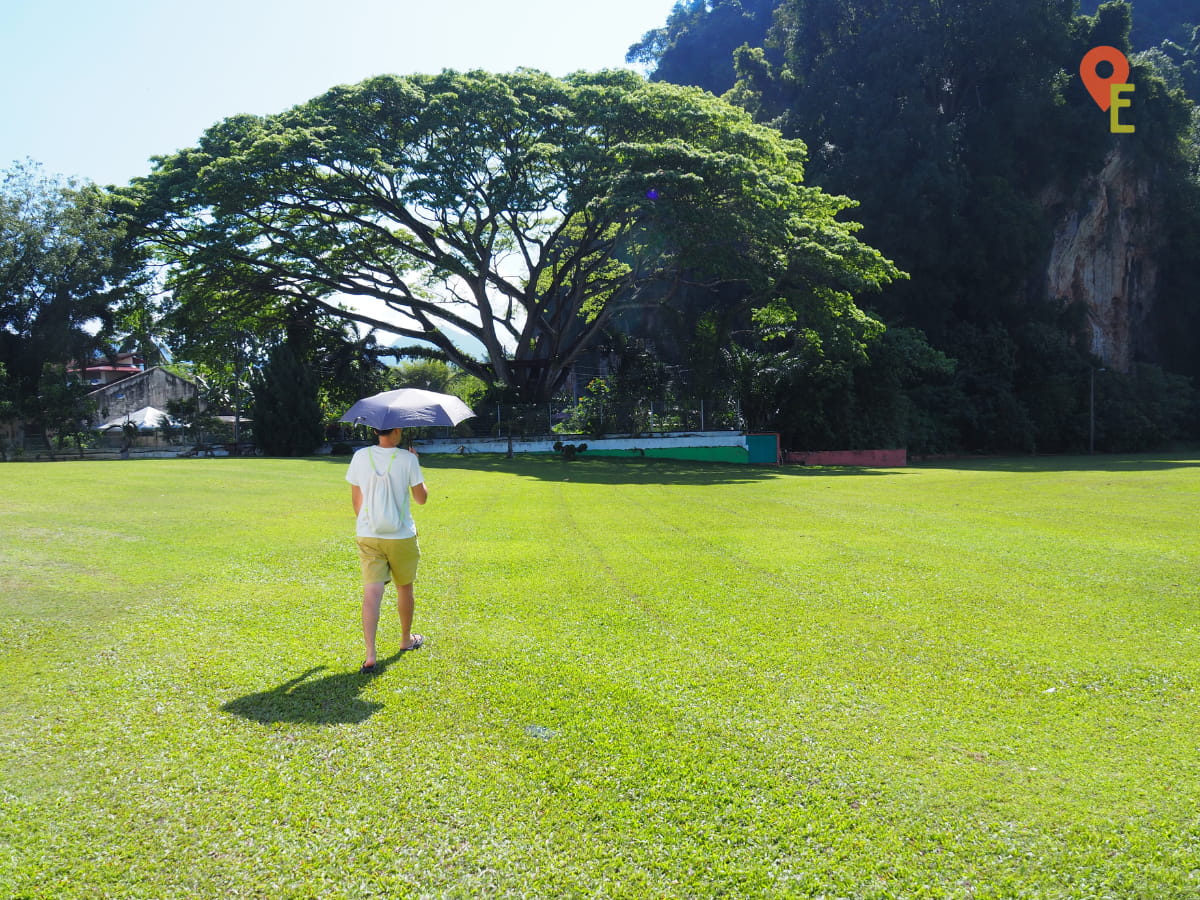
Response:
[0,0,674,184]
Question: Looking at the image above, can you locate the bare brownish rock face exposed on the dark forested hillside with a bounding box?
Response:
[1043,143,1163,372]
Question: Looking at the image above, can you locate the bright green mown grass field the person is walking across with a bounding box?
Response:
[0,457,1200,900]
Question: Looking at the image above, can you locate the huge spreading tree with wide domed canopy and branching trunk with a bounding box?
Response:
[127,71,896,400]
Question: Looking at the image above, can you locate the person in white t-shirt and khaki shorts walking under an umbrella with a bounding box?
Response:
[346,428,428,674]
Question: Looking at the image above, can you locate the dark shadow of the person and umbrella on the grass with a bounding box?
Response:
[221,650,404,725]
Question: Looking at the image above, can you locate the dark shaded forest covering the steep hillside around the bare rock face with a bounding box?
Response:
[631,0,1200,450]
